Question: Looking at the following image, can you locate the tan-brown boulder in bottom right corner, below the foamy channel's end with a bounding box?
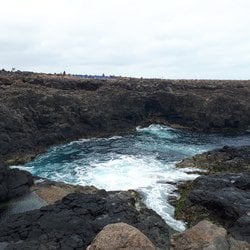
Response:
[171,220,250,250]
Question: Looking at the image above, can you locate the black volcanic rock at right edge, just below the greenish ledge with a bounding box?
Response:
[189,173,250,222]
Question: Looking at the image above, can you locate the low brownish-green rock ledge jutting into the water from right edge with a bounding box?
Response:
[177,146,250,174]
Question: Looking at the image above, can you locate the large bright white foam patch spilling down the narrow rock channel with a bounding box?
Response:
[72,155,198,231]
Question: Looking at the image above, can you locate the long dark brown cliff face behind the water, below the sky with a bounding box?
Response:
[0,72,250,159]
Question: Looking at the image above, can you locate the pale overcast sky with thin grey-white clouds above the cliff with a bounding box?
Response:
[0,0,250,79]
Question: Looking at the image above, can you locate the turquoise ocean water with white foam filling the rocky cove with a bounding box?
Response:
[15,125,250,231]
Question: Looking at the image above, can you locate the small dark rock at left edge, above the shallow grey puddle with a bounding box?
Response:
[0,166,33,203]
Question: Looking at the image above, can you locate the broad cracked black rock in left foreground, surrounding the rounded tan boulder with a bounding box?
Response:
[0,191,171,249]
